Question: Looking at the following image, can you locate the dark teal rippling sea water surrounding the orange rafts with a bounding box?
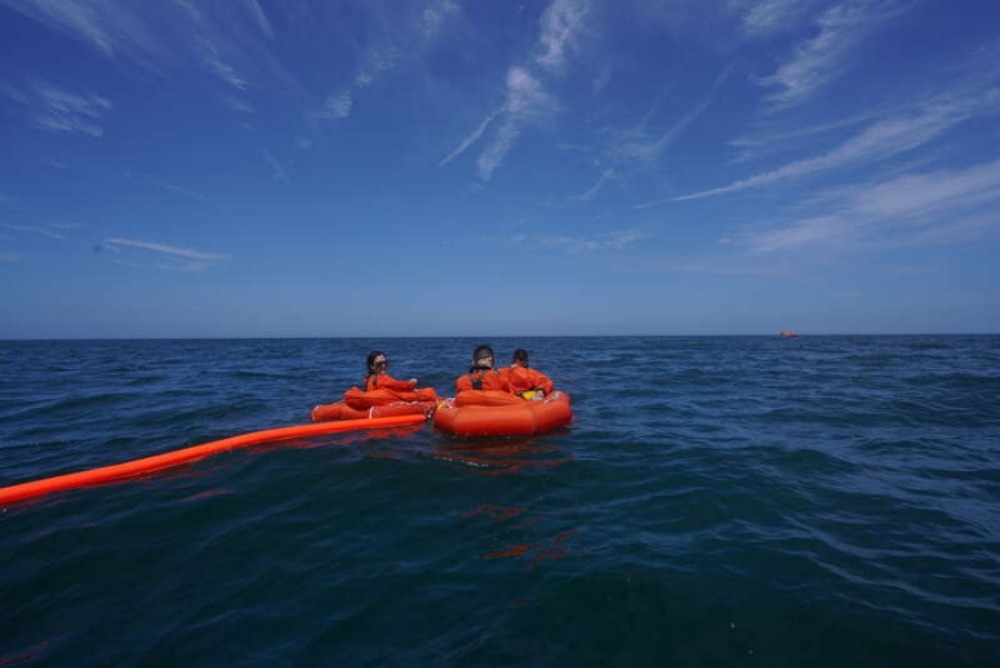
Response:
[0,336,1000,668]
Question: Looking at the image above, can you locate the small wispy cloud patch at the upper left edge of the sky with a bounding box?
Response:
[0,81,111,137]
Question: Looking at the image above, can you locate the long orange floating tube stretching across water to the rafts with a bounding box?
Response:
[0,414,425,505]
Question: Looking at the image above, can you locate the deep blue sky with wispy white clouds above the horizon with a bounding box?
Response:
[0,0,1000,338]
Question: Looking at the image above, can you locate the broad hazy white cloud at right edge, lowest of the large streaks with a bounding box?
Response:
[745,161,1000,252]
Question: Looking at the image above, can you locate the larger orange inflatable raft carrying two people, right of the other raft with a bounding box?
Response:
[434,390,573,438]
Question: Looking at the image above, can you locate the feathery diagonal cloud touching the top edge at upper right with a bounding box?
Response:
[762,0,901,107]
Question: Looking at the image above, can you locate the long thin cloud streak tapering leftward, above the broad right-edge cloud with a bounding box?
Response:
[664,82,1000,201]
